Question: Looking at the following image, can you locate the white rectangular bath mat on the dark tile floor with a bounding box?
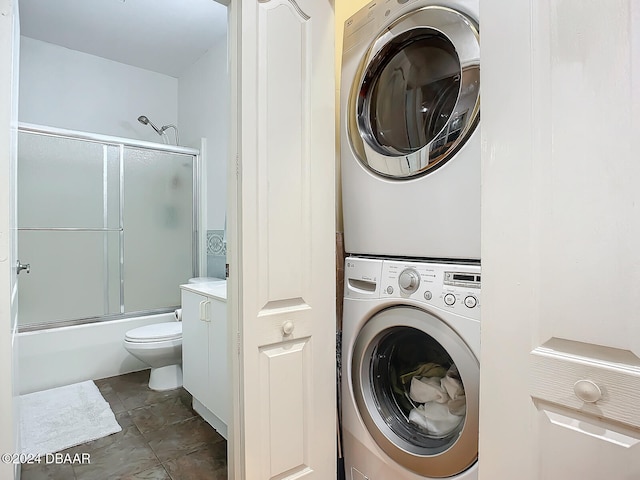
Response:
[19,380,122,454]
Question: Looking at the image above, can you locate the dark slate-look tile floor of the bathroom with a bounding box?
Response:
[22,370,227,480]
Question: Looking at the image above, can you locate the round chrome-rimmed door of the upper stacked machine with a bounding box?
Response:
[346,6,480,180]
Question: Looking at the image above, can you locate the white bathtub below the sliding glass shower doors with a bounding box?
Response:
[17,313,175,395]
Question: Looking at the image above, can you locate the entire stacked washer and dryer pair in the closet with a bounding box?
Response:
[341,0,481,480]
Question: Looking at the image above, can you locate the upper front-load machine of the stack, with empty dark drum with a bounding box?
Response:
[340,0,480,260]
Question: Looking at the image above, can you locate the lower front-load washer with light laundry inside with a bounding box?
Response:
[342,257,480,480]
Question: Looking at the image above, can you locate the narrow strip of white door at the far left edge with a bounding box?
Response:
[0,0,20,478]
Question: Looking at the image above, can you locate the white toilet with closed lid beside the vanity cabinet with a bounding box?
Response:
[124,322,182,390]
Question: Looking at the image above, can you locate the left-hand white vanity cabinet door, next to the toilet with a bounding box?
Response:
[182,290,211,405]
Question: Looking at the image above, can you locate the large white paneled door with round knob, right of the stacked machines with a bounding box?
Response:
[479,0,640,480]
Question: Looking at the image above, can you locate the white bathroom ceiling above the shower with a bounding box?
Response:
[19,0,227,77]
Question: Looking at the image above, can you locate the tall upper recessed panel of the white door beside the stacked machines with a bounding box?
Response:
[257,1,311,308]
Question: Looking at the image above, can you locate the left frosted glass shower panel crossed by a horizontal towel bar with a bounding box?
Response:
[18,132,122,326]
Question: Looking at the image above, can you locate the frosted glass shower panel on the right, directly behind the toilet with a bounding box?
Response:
[123,147,196,313]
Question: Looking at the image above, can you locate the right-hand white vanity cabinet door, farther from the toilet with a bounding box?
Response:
[208,299,231,425]
